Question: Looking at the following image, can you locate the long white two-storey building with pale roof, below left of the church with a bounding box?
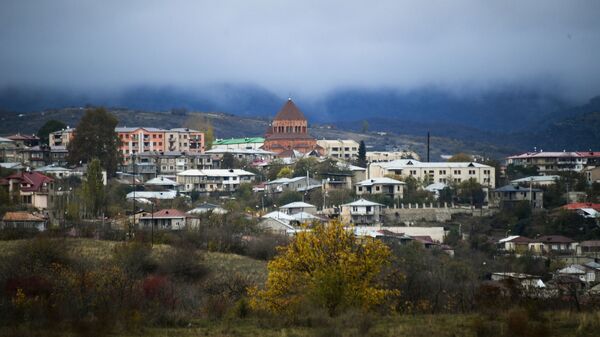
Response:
[177,169,254,193]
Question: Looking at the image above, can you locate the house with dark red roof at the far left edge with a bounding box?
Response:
[0,172,54,210]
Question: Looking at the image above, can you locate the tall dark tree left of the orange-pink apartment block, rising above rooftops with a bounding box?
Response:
[67,108,121,177]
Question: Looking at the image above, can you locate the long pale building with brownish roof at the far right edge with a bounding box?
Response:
[506,151,600,175]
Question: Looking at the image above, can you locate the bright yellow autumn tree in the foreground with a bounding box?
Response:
[250,222,395,316]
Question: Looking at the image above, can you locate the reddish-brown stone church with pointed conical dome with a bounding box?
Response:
[263,98,321,155]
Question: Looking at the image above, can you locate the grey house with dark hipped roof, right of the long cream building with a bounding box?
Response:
[490,185,544,208]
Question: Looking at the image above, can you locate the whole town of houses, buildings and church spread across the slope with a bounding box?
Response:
[0,98,600,334]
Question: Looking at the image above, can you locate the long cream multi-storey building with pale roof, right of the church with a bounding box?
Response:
[369,159,496,188]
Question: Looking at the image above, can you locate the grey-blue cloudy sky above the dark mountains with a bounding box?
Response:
[0,0,600,99]
